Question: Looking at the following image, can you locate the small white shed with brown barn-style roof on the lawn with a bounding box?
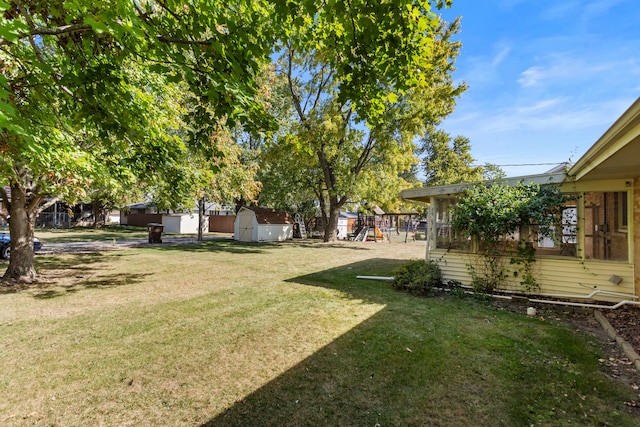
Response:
[234,207,295,242]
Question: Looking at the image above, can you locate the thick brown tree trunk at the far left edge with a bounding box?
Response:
[3,184,37,283]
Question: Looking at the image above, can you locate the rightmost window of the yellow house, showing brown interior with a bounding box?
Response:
[584,191,629,261]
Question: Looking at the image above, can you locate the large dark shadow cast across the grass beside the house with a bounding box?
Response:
[201,259,637,427]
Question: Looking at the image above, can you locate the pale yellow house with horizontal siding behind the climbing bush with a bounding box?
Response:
[401,98,640,301]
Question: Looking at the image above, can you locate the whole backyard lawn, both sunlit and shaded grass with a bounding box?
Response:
[0,240,640,426]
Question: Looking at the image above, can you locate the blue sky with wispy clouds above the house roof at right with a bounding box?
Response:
[438,0,640,176]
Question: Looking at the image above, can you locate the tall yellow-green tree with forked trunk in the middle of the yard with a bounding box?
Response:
[279,13,465,241]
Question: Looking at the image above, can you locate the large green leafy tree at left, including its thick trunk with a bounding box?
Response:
[0,0,280,281]
